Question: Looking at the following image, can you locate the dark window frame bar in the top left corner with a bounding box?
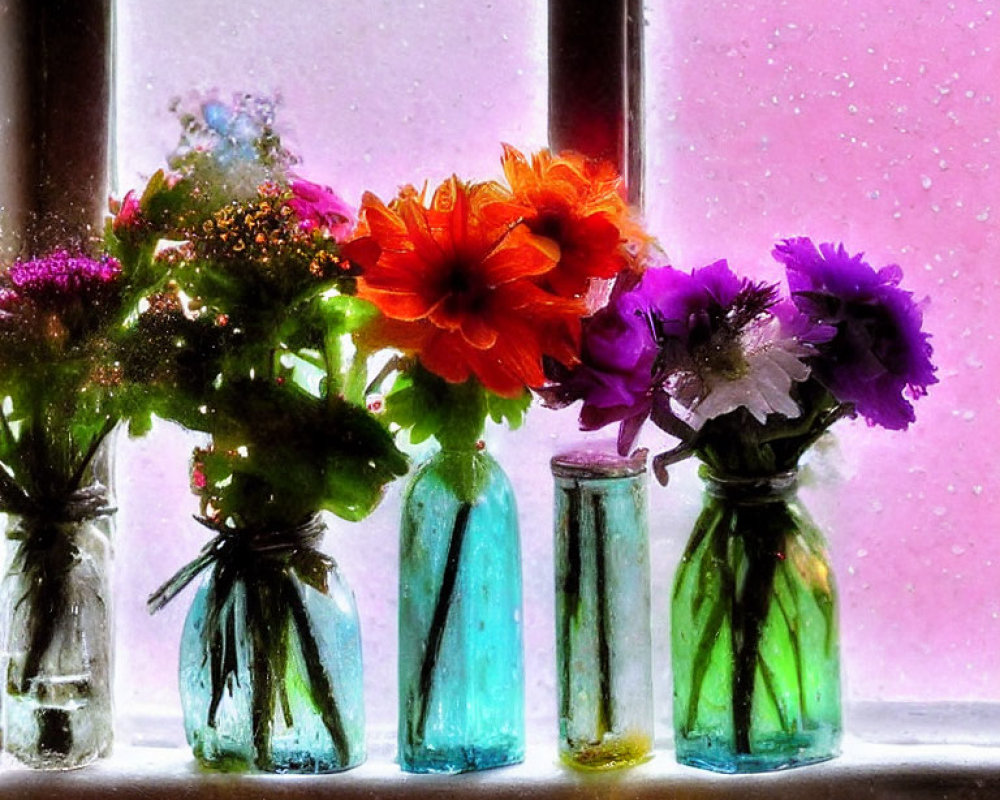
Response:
[0,0,112,255]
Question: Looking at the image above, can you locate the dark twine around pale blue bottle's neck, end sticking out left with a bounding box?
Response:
[146,514,333,614]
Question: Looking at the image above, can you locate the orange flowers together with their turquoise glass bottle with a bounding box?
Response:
[352,147,635,771]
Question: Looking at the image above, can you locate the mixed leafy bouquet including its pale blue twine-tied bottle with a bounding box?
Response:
[112,98,406,772]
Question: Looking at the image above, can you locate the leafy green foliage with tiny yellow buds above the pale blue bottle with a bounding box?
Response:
[109,98,406,528]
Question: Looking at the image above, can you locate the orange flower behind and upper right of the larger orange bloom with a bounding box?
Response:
[479,145,631,297]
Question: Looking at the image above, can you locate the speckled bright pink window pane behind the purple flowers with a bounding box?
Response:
[647,0,1000,700]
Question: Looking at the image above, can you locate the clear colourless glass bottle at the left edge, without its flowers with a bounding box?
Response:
[0,485,113,769]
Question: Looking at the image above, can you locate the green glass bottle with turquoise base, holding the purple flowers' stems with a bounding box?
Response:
[671,467,841,773]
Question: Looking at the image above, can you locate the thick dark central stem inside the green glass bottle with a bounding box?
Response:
[732,516,778,755]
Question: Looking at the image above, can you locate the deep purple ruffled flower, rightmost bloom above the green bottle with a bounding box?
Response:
[774,237,937,430]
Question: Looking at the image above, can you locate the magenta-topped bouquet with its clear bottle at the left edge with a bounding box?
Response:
[0,251,164,767]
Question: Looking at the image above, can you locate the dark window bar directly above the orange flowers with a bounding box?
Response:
[549,0,643,203]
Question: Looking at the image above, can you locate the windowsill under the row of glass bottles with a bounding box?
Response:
[0,737,1000,800]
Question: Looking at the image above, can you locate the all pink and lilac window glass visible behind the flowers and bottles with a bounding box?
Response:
[116,0,1000,738]
